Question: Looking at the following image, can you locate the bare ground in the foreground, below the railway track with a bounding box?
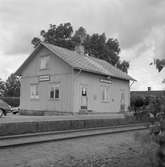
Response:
[0,130,158,167]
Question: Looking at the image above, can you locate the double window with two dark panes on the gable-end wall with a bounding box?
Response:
[50,84,60,100]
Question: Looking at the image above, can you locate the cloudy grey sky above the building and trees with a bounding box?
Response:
[0,0,165,90]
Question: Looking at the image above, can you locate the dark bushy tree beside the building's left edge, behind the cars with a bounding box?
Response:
[4,74,20,97]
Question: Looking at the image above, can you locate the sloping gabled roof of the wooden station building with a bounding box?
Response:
[16,43,135,80]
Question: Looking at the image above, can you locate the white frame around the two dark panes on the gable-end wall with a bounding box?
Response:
[49,83,61,100]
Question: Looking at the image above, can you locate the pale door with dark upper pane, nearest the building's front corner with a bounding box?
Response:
[80,84,88,110]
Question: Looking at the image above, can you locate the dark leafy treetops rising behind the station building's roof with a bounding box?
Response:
[32,23,129,72]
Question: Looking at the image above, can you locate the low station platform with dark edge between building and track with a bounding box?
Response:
[0,113,142,136]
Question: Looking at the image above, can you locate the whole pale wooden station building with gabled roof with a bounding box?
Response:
[16,43,134,114]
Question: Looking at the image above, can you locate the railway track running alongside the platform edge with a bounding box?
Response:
[0,123,147,148]
